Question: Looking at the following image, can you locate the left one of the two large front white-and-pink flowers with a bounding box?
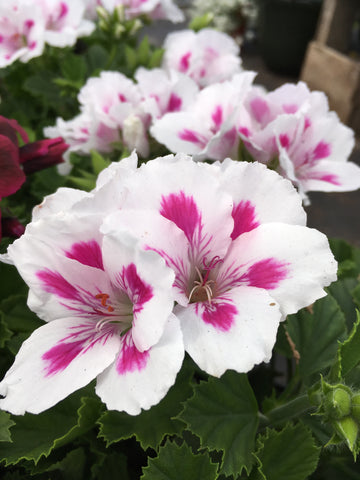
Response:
[0,174,184,415]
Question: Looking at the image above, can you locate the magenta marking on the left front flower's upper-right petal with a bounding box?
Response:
[117,263,154,315]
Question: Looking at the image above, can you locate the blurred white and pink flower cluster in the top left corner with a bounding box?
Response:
[0,0,184,68]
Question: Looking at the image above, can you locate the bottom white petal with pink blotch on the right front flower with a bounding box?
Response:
[175,286,281,377]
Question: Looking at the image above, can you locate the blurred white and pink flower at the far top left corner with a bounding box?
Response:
[0,0,45,68]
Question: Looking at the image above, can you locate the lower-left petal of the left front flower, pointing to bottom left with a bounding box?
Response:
[0,318,120,415]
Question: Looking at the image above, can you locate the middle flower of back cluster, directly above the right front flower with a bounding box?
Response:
[150,72,255,161]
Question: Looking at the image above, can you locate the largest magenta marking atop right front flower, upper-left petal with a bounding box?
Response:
[160,191,201,241]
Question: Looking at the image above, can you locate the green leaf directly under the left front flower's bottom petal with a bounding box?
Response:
[99,362,192,450]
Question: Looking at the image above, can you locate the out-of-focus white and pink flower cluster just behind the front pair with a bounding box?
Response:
[44,29,360,203]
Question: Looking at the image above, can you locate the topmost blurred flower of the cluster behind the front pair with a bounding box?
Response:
[162,28,241,87]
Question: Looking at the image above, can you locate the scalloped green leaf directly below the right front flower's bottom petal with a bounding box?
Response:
[178,371,258,475]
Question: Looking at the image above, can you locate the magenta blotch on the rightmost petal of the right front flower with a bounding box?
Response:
[240,258,288,290]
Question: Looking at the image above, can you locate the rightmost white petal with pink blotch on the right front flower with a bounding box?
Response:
[222,223,337,315]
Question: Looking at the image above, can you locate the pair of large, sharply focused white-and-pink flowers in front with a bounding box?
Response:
[0,153,337,414]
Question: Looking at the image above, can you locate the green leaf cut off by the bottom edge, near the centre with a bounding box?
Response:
[141,442,217,480]
